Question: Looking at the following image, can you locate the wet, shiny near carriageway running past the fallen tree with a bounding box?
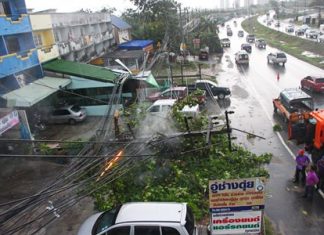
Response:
[217,18,324,235]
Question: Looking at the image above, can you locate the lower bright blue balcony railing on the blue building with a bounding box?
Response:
[0,49,39,78]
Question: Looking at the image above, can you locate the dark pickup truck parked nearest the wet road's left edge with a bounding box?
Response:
[187,80,231,99]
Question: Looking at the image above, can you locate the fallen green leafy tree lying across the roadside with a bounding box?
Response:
[93,96,271,219]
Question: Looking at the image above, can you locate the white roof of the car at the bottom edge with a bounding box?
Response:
[115,202,187,225]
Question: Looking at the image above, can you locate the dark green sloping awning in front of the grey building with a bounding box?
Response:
[43,60,118,83]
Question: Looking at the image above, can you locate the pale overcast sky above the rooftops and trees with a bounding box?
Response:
[25,0,240,15]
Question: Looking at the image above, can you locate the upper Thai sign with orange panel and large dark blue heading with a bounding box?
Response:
[209,178,265,212]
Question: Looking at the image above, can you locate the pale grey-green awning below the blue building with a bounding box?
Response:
[1,77,71,107]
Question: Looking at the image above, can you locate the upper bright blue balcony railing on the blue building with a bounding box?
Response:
[0,15,32,35]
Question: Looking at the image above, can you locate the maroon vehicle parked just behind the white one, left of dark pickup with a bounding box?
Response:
[147,86,188,102]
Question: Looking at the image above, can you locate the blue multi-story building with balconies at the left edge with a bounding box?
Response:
[0,0,43,94]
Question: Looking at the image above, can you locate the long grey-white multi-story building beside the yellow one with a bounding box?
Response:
[49,12,115,62]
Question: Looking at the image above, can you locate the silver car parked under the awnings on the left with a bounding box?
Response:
[47,105,87,125]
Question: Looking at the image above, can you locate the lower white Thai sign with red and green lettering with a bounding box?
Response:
[211,211,262,235]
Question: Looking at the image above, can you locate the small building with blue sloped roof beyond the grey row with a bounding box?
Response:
[111,15,132,44]
